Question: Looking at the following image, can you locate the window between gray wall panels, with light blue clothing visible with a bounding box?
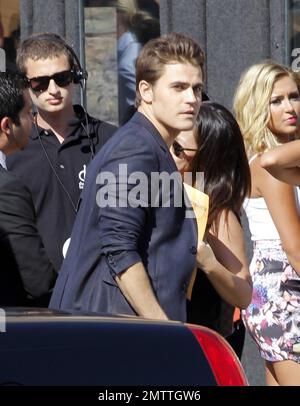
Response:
[84,0,160,124]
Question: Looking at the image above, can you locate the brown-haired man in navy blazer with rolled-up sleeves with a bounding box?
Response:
[50,33,204,321]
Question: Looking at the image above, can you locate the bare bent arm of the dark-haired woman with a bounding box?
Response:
[197,211,252,309]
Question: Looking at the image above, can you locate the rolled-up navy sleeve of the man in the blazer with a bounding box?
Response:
[98,135,158,276]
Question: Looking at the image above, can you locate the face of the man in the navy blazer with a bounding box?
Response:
[144,62,203,138]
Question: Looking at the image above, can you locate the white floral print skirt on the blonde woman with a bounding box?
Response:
[242,240,300,363]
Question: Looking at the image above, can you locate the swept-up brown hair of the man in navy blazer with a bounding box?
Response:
[135,32,205,107]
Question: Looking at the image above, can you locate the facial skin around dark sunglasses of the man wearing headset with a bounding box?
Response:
[26,54,74,113]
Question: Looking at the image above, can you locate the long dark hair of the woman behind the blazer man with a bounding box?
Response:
[191,102,251,230]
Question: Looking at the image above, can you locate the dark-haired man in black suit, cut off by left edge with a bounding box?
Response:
[0,72,56,306]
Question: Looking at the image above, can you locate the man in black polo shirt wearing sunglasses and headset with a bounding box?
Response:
[8,33,116,271]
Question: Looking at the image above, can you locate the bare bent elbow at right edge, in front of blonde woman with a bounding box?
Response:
[260,140,300,185]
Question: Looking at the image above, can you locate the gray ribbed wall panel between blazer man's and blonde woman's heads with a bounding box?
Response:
[160,0,286,108]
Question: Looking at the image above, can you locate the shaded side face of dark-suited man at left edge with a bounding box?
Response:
[7,90,32,155]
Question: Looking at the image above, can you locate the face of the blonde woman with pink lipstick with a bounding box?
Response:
[268,76,300,143]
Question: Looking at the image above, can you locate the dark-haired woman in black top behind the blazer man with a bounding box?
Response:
[171,102,252,356]
